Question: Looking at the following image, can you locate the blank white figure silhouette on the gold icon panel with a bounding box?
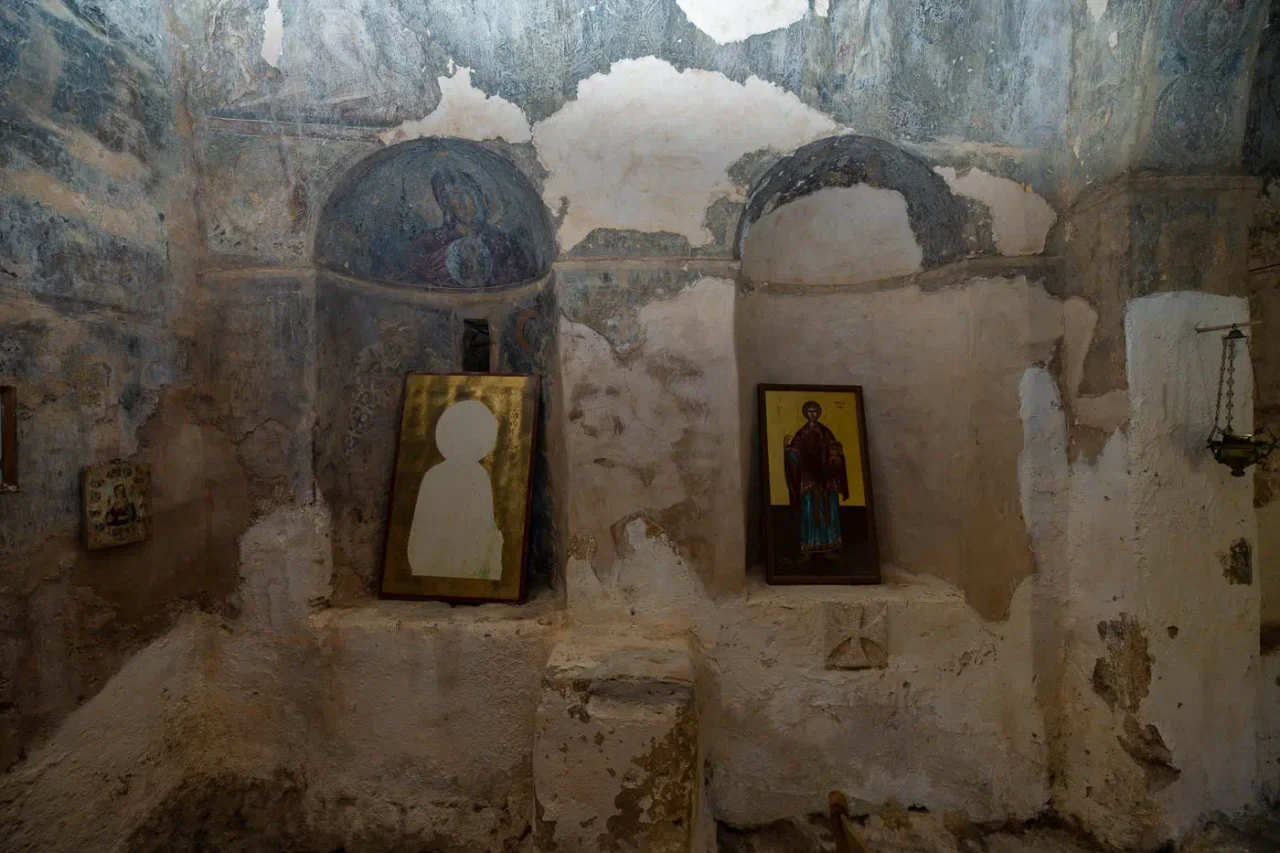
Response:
[408,400,502,580]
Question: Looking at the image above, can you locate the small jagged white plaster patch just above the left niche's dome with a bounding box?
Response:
[378,65,531,145]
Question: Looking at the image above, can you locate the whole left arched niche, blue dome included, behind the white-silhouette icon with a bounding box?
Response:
[312,138,558,596]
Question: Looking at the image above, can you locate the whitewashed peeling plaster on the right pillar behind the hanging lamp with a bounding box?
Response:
[1030,292,1266,848]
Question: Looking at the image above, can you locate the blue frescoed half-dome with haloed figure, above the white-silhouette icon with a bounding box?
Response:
[314,138,556,292]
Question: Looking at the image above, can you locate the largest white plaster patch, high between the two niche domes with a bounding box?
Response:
[534,56,840,250]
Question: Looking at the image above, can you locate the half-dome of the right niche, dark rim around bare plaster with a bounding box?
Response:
[735,136,968,284]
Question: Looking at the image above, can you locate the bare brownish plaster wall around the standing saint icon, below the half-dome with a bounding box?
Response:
[737,274,1064,619]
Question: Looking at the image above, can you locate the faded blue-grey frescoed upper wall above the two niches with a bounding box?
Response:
[175,0,1073,172]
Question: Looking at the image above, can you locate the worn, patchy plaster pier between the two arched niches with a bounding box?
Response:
[559,278,742,596]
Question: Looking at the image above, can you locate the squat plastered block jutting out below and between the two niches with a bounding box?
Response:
[534,635,698,853]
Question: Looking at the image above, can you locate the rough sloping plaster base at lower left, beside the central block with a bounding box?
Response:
[0,508,554,852]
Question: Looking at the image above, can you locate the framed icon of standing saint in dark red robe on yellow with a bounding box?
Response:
[759,386,881,584]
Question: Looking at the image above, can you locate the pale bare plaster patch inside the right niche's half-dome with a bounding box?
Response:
[742,183,924,284]
